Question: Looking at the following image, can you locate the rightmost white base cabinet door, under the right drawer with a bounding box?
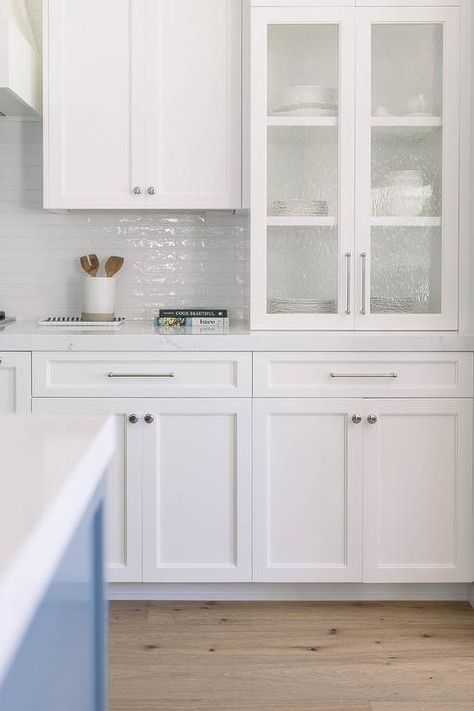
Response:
[364,399,474,583]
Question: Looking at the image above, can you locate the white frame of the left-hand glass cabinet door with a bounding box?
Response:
[250,7,355,330]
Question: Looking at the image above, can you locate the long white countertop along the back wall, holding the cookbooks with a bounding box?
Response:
[0,321,474,352]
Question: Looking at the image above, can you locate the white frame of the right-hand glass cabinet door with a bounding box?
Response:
[355,7,460,331]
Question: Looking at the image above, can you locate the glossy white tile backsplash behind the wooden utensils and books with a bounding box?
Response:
[0,119,249,320]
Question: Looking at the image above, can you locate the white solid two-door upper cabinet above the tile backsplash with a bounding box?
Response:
[44,0,241,209]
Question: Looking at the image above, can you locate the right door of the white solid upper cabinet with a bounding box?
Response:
[145,0,242,209]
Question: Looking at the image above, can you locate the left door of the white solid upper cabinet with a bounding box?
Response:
[44,0,145,208]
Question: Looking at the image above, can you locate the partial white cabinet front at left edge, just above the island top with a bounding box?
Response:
[0,352,31,415]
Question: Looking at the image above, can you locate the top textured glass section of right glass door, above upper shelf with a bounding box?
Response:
[372,24,443,116]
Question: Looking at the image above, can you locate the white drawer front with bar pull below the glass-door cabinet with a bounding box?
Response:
[254,353,473,397]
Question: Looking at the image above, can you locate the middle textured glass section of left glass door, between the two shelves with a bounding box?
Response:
[267,126,338,215]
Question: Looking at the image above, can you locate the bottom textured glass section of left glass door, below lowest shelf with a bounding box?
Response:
[267,227,338,314]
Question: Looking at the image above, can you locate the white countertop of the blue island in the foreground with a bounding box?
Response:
[0,415,115,683]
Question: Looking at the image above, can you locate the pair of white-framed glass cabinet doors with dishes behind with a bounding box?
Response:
[251,7,459,330]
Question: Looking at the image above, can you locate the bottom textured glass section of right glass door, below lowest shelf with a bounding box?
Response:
[370,227,442,314]
